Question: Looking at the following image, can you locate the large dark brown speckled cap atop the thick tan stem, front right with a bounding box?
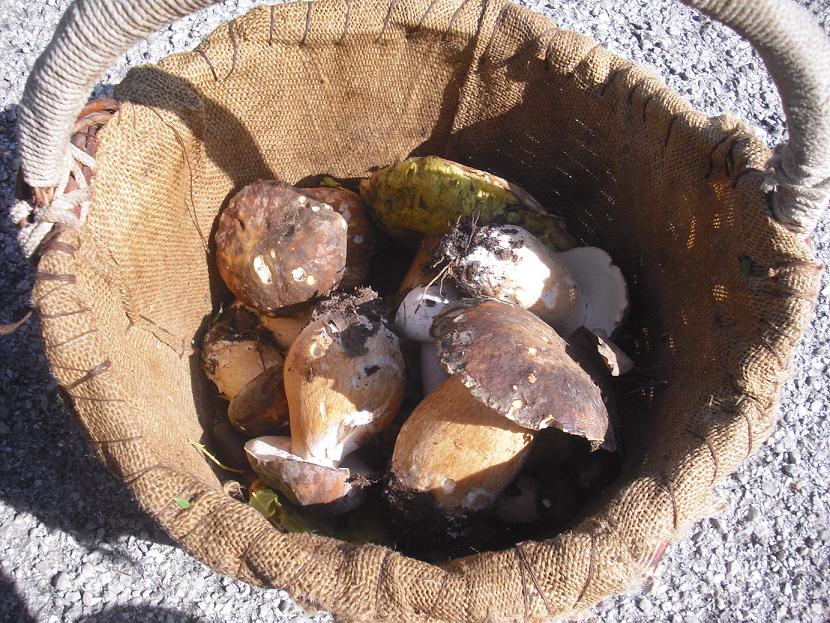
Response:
[431,298,608,443]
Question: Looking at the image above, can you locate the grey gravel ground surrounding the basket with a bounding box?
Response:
[0,0,830,623]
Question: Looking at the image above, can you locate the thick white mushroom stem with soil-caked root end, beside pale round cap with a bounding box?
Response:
[436,224,586,337]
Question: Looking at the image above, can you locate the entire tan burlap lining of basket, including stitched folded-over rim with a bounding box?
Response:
[29,0,819,623]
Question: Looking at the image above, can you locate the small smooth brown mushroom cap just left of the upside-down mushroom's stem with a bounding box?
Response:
[228,361,288,437]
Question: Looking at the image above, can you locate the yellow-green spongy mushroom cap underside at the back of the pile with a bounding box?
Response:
[360,156,575,250]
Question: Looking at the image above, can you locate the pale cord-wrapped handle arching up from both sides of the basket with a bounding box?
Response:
[14,0,830,233]
